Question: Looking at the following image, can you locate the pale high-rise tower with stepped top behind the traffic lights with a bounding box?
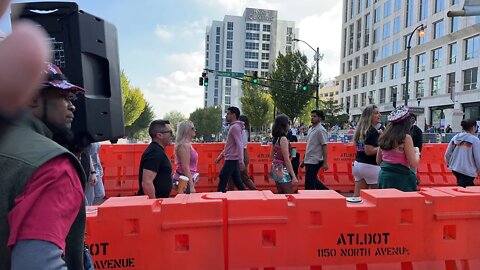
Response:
[204,8,298,111]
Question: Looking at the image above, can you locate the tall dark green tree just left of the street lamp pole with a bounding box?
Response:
[269,51,315,121]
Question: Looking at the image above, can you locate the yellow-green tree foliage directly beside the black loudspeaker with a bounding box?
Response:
[120,70,146,127]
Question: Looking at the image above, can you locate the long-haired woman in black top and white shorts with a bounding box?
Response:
[352,105,380,197]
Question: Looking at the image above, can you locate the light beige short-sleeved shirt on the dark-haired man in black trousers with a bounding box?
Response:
[304,124,327,164]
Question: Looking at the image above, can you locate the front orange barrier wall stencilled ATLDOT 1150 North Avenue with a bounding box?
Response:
[86,187,480,270]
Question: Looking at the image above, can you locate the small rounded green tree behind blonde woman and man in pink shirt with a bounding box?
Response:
[190,106,223,141]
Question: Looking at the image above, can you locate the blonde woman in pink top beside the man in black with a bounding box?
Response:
[173,121,199,193]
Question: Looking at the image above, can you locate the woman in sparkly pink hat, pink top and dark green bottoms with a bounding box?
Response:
[377,105,420,191]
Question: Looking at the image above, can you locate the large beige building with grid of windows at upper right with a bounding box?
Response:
[337,0,480,131]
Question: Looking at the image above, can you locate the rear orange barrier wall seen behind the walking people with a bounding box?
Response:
[100,143,480,197]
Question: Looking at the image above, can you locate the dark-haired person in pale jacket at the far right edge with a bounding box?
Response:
[445,120,480,187]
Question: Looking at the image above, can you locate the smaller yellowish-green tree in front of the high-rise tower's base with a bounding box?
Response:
[240,78,273,131]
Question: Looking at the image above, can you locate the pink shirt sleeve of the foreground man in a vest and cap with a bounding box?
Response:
[8,155,85,251]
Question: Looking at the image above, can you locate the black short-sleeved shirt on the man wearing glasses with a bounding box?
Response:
[137,142,172,198]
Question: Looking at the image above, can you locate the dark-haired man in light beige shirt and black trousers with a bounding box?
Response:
[302,110,328,190]
